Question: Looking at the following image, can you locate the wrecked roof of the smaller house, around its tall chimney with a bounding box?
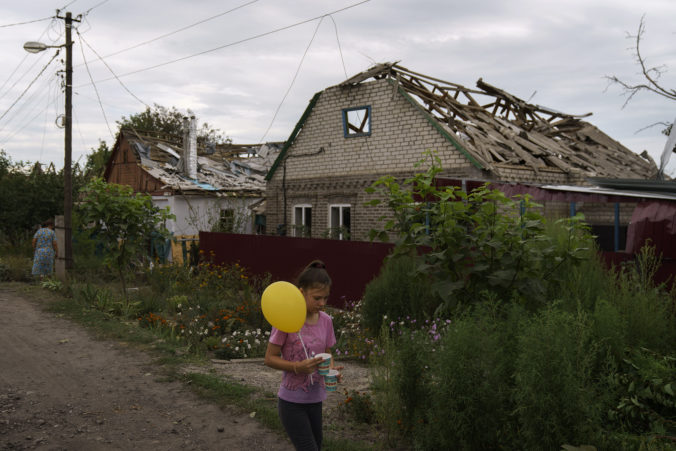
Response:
[107,130,282,196]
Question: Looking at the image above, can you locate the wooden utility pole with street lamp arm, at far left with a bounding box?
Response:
[23,10,79,271]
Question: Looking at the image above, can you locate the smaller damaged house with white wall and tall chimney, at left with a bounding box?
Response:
[104,121,281,262]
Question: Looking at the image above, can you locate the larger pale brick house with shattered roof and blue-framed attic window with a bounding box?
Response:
[266,63,657,245]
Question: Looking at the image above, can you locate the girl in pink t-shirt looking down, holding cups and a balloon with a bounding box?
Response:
[265,260,342,450]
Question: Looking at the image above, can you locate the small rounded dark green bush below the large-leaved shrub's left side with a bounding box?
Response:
[362,256,440,331]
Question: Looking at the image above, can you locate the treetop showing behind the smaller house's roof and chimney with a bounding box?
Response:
[117,104,230,145]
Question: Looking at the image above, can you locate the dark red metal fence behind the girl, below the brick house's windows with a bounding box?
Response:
[199,232,393,307]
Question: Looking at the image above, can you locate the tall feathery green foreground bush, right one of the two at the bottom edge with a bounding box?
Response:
[514,308,607,450]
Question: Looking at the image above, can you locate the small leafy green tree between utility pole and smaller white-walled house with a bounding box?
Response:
[77,178,175,302]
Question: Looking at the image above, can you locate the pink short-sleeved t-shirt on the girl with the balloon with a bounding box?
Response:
[270,312,336,404]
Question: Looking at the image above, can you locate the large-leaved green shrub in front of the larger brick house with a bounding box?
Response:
[367,152,588,314]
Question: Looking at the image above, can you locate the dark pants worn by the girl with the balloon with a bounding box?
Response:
[277,399,322,451]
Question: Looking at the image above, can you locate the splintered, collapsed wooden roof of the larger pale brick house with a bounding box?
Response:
[339,63,657,179]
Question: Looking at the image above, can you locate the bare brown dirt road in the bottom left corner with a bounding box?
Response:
[0,285,292,451]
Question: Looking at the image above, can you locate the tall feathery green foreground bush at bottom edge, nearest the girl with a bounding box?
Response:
[415,304,520,450]
